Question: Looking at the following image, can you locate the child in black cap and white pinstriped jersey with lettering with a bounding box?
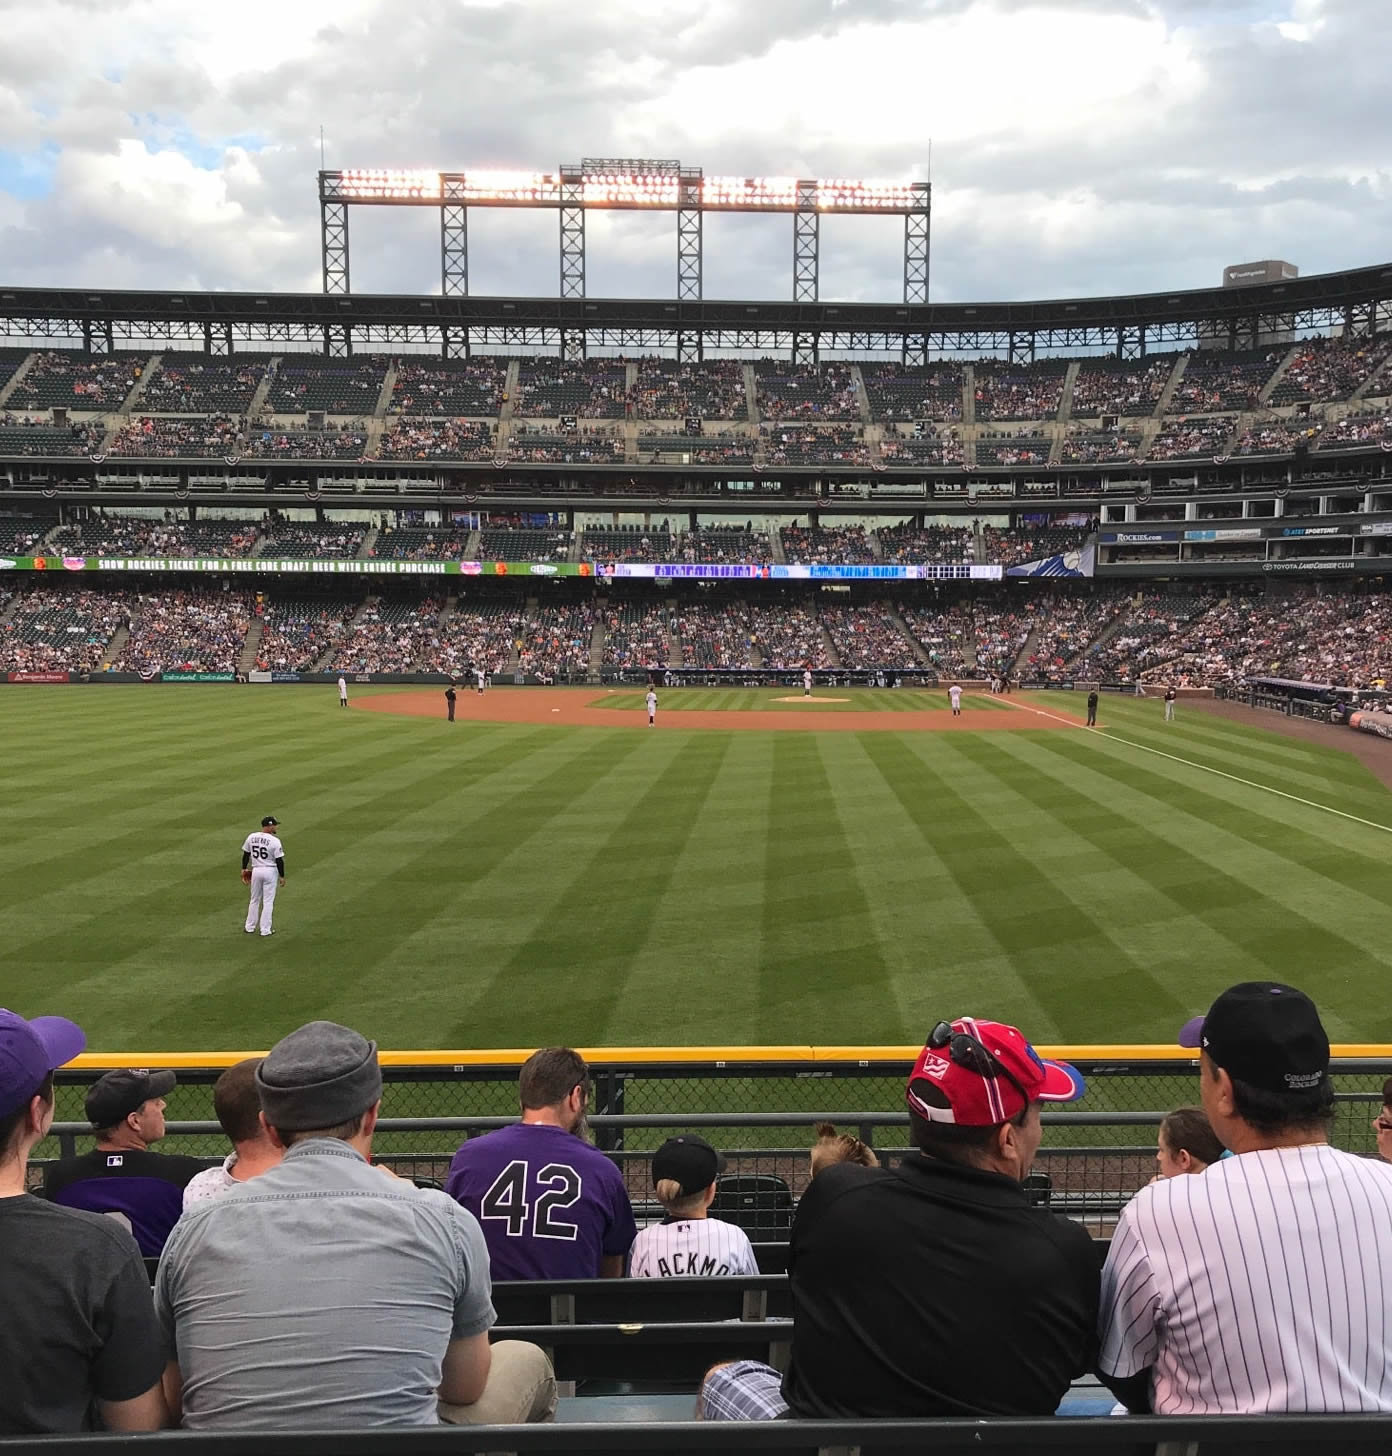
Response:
[629,1133,759,1278]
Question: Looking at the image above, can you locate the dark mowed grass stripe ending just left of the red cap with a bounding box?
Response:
[756,734,890,1041]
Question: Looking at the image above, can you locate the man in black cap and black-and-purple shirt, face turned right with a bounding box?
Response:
[44,1069,204,1258]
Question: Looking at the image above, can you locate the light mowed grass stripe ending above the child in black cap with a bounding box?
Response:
[604,732,775,1048]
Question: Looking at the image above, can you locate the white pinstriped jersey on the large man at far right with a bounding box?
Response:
[1099,1144,1392,1415]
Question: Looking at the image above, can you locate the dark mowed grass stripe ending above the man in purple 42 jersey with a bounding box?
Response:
[462,734,729,1045]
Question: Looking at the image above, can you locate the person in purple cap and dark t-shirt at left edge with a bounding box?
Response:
[0,1010,169,1437]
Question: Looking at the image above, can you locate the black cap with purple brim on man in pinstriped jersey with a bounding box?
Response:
[1179,981,1329,1093]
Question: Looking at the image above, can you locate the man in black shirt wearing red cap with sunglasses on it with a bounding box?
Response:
[700,1018,1101,1421]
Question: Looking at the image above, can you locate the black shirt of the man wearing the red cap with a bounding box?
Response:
[783,1153,1101,1420]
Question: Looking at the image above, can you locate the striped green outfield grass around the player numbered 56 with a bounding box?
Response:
[0,684,1392,1051]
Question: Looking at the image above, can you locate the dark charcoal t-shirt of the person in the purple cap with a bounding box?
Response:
[0,1194,165,1436]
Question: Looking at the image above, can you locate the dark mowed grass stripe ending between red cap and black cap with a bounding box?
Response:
[866,734,1179,1038]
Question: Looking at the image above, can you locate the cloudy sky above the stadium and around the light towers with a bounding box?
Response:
[0,0,1392,301]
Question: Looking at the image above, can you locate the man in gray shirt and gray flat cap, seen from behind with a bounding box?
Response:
[154,1021,556,1431]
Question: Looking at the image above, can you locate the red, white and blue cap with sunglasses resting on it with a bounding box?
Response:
[904,1016,1086,1127]
